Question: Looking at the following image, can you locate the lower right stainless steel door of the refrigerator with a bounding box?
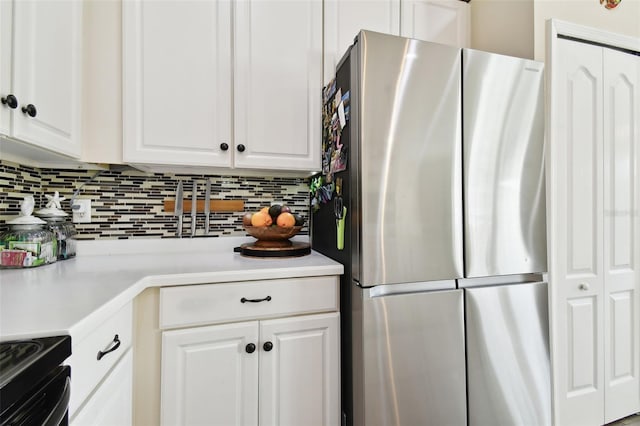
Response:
[464,283,551,426]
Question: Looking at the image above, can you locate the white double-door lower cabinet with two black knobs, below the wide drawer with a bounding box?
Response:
[161,312,340,426]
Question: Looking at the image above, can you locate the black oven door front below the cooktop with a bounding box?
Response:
[0,365,71,426]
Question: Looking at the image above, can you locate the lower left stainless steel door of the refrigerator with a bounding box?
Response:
[353,283,466,426]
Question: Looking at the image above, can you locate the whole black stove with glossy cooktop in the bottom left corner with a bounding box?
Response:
[0,336,71,425]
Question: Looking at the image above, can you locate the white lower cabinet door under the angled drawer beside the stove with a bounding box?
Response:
[71,350,133,426]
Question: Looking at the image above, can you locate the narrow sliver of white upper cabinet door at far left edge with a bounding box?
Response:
[0,1,15,135]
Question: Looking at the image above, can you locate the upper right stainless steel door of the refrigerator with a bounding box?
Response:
[462,49,547,277]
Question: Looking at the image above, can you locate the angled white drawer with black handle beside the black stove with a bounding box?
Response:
[67,303,133,416]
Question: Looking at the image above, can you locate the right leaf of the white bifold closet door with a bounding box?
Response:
[603,49,640,423]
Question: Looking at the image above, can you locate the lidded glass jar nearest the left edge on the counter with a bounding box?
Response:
[0,196,58,268]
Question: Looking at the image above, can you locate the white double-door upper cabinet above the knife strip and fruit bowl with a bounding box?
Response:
[123,0,322,171]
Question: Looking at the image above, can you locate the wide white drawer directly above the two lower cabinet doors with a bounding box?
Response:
[160,276,338,328]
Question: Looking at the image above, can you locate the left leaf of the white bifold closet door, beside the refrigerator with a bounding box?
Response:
[546,39,604,426]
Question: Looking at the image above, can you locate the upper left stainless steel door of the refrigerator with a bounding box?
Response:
[350,31,463,287]
